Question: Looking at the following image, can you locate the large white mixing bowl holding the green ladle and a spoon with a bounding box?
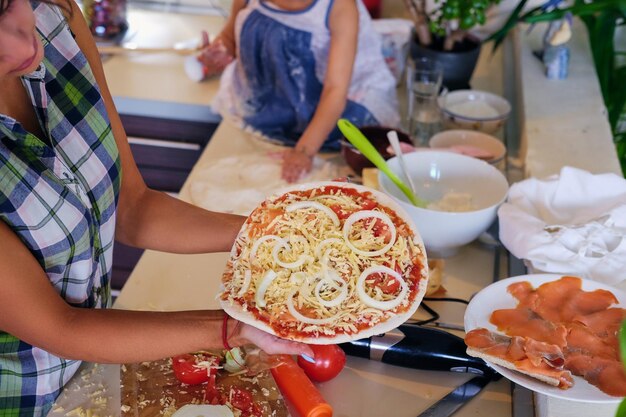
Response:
[378,150,509,258]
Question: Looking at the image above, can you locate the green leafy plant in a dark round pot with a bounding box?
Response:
[404,0,500,90]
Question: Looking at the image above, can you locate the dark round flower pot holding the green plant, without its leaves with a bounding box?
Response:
[411,34,481,90]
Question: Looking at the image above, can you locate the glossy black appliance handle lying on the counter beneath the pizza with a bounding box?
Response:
[340,325,495,375]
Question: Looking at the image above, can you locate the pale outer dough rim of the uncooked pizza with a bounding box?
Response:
[220,181,428,345]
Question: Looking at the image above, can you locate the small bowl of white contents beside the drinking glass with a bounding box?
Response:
[439,90,511,133]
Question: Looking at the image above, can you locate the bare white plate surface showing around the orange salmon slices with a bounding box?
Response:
[465,274,626,403]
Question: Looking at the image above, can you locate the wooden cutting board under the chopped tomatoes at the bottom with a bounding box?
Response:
[120,359,289,417]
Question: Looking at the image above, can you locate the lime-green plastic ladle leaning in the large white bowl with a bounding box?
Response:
[337,119,428,208]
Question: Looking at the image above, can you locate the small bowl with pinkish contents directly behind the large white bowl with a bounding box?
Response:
[428,129,506,165]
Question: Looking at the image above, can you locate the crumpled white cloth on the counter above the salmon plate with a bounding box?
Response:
[498,167,626,285]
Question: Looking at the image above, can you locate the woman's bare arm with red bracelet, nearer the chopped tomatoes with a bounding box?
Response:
[0,221,311,363]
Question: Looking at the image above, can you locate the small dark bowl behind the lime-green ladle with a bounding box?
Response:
[341,126,413,175]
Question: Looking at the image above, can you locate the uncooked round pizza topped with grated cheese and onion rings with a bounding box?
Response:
[220,182,428,344]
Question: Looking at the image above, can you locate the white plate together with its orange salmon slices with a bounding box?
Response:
[465,274,626,403]
